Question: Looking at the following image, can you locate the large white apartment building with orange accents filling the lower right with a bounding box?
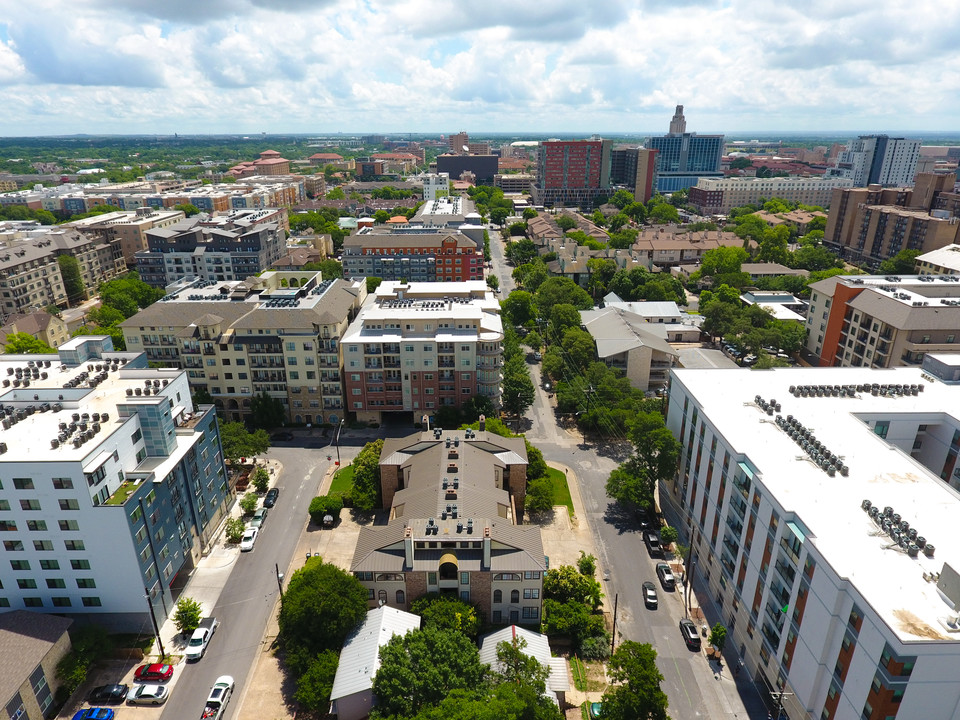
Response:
[659,366,960,720]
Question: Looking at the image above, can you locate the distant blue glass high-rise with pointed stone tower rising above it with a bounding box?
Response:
[645,105,723,193]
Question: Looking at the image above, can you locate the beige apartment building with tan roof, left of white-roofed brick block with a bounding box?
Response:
[120,272,366,424]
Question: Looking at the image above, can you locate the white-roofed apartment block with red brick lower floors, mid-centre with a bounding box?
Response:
[341,280,503,422]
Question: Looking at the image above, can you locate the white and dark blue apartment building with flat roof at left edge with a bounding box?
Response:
[0,336,232,632]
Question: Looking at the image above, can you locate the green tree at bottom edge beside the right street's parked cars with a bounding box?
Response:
[602,640,669,720]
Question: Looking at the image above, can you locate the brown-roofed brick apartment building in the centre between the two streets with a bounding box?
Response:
[350,429,547,624]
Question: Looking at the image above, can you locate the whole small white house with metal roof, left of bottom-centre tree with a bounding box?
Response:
[330,605,420,720]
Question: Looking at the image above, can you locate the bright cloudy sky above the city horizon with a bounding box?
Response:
[0,0,960,137]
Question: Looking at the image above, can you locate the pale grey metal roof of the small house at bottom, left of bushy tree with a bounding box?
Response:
[330,605,420,701]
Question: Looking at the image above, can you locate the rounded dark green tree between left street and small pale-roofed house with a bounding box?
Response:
[278,556,367,673]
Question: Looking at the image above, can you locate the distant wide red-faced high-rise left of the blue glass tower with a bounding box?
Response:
[533,139,612,207]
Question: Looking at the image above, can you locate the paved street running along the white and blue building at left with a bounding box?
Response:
[162,437,356,720]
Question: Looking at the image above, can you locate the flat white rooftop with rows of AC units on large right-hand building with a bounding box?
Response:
[671,368,960,642]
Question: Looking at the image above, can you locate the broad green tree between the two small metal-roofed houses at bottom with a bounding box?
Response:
[371,628,489,718]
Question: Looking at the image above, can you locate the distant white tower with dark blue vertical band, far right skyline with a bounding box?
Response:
[829,135,920,187]
